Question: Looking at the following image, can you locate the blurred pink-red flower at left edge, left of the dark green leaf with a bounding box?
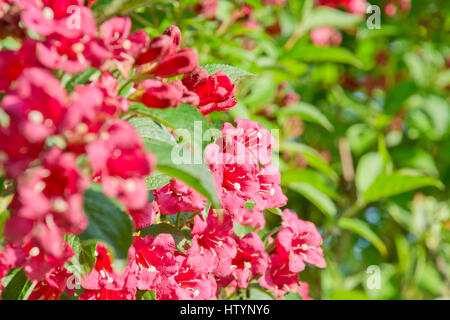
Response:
[10,147,87,238]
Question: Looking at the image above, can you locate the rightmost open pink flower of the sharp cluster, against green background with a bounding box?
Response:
[276,209,326,272]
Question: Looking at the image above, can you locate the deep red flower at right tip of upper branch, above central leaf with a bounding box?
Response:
[182,68,237,114]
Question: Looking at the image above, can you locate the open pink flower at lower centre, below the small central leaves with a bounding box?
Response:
[188,211,237,277]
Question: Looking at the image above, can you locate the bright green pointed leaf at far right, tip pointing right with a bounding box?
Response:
[363,171,443,203]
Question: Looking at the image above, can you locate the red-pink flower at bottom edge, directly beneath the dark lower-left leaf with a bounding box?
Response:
[79,244,137,300]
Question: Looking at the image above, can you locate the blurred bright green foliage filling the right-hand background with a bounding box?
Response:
[124,0,450,299]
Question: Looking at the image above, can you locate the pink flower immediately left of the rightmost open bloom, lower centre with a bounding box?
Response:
[232,232,269,289]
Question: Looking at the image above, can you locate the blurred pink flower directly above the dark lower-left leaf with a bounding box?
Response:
[86,120,155,210]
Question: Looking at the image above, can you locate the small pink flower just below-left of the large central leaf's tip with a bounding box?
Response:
[153,179,206,215]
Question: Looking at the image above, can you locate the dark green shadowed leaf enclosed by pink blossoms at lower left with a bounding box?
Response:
[80,184,133,271]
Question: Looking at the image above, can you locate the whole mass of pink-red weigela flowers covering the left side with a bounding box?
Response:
[0,0,325,300]
